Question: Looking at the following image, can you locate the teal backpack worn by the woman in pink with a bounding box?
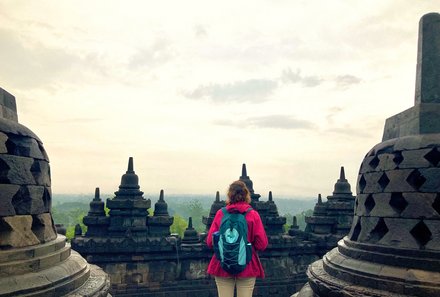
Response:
[212,207,252,275]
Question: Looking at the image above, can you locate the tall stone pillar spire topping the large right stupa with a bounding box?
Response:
[414,13,440,105]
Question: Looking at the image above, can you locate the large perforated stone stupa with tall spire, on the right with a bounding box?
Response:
[298,13,440,297]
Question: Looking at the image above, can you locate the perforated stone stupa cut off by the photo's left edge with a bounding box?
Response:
[0,88,110,297]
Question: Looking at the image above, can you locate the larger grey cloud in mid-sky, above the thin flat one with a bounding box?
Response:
[183,79,278,103]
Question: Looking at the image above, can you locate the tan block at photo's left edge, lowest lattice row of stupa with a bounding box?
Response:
[0,215,40,248]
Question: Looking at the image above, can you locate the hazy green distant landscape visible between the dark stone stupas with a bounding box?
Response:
[52,194,316,237]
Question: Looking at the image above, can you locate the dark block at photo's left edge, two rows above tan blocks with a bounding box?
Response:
[0,154,35,185]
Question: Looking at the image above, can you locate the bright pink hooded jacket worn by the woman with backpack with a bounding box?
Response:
[206,202,267,278]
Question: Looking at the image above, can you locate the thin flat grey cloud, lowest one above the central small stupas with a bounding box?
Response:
[214,115,316,130]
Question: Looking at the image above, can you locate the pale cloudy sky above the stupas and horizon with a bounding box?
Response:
[0,0,440,200]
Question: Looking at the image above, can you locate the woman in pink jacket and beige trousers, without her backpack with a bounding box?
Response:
[206,180,267,297]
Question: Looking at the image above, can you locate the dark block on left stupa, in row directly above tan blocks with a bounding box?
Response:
[12,186,49,215]
